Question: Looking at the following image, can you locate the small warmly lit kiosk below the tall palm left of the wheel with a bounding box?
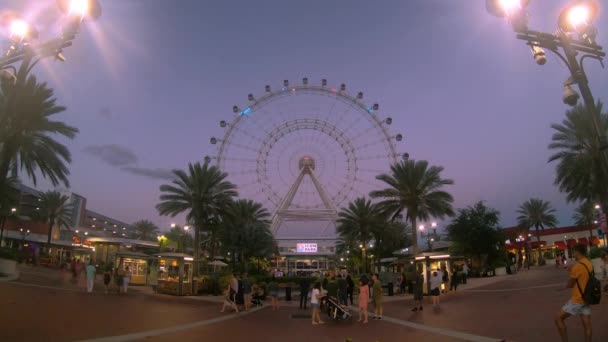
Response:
[156,253,194,296]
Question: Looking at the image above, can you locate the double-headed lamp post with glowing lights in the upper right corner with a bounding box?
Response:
[486,0,608,163]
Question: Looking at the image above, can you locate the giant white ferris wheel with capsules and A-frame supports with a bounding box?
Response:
[205,78,409,233]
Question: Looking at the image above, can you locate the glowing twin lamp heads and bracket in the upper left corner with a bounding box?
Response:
[0,0,101,76]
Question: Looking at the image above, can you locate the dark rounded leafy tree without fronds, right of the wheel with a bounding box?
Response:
[446,202,504,263]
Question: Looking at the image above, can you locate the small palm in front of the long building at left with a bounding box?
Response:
[40,191,72,245]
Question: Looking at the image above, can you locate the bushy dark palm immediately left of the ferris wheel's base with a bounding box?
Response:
[222,199,275,271]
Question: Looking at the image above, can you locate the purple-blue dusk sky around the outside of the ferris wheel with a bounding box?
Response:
[0,0,608,229]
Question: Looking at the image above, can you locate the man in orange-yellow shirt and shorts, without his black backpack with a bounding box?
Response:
[555,244,593,342]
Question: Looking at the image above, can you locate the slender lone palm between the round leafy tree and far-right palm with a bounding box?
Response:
[517,198,557,261]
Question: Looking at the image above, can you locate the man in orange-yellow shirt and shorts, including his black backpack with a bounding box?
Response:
[555,244,602,342]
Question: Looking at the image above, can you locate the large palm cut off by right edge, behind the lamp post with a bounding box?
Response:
[549,101,608,208]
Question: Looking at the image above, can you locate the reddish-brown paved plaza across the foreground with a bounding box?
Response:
[0,267,608,341]
